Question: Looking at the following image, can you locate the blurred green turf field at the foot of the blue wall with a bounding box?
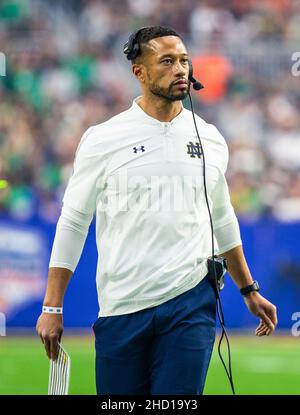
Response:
[0,334,300,395]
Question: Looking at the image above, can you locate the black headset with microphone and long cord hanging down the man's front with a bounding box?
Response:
[123,27,235,395]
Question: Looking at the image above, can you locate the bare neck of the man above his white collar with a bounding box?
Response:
[137,95,182,122]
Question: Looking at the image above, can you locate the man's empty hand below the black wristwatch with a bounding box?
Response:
[244,292,278,336]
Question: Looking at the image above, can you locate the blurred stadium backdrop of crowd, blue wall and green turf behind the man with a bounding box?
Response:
[0,0,300,394]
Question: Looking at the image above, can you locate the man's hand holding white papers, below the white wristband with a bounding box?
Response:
[36,313,63,360]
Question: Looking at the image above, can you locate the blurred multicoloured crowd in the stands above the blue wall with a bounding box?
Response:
[0,0,300,222]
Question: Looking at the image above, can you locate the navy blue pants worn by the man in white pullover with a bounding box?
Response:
[93,277,216,395]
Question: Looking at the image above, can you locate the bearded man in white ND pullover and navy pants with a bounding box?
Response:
[37,27,277,394]
